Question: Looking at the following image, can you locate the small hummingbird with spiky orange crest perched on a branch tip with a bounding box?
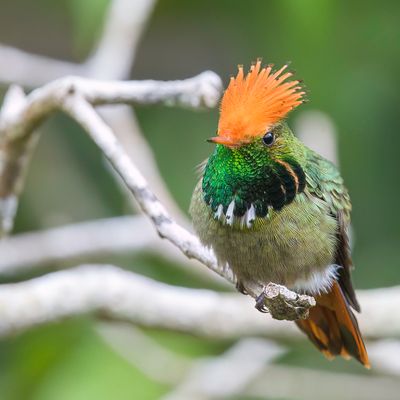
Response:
[189,60,370,368]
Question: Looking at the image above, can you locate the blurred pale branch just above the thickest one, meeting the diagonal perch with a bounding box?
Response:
[0,215,222,286]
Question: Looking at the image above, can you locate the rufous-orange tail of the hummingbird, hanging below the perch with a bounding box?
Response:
[296,282,370,368]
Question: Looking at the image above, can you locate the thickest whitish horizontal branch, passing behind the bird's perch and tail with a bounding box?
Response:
[0,265,400,340]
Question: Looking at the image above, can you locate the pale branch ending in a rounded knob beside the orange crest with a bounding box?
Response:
[0,71,221,232]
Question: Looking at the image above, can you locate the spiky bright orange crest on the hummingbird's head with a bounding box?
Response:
[218,60,305,145]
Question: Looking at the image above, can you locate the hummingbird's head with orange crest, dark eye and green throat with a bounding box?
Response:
[203,60,305,225]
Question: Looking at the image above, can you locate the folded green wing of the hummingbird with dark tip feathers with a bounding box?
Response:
[306,151,360,311]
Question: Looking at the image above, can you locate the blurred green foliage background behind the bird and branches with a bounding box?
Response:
[0,0,400,400]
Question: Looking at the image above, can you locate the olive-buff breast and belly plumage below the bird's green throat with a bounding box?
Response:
[190,182,337,285]
